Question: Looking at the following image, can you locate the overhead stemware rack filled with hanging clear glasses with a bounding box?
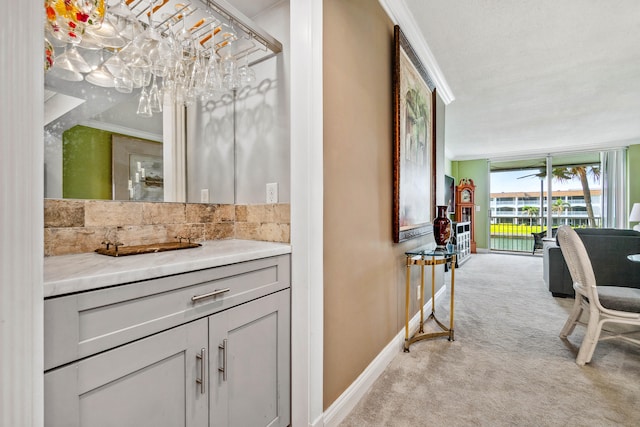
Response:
[45,0,282,117]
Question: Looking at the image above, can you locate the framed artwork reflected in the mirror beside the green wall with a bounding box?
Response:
[111,135,164,202]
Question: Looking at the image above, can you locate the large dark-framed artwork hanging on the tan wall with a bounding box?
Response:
[393,25,436,243]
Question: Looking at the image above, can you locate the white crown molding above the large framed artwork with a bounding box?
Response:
[378,0,456,105]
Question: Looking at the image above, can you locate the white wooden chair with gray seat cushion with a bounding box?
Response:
[557,225,640,365]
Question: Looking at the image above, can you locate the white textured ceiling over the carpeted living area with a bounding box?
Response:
[402,0,640,160]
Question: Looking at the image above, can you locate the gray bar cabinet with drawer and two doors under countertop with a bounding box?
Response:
[44,255,290,427]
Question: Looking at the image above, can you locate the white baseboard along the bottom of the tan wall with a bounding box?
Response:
[320,286,446,427]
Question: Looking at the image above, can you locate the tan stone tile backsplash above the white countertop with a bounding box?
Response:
[44,199,290,256]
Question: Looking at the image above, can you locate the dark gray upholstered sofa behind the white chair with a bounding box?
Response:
[543,228,640,297]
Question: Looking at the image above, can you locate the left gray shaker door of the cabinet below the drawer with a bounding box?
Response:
[44,319,209,427]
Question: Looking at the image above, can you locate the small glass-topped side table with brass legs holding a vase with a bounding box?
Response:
[404,243,456,353]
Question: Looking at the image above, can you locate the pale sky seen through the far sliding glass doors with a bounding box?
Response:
[490,169,600,193]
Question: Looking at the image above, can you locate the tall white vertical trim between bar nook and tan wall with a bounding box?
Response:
[289,0,324,427]
